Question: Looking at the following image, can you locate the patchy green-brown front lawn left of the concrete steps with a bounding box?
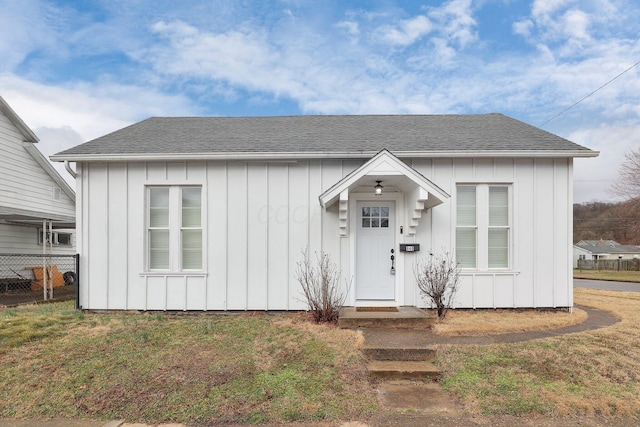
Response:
[0,302,377,425]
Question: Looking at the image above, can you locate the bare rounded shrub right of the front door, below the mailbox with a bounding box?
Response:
[414,251,460,319]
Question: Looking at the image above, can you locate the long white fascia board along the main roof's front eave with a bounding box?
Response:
[50,150,600,162]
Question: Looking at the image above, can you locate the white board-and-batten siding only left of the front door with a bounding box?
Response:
[76,160,362,310]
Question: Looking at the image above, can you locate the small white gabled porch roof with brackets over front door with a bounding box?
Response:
[318,149,450,236]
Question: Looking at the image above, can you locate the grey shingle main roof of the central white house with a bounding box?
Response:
[52,114,597,160]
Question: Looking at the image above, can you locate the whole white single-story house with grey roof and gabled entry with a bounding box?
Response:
[52,114,598,310]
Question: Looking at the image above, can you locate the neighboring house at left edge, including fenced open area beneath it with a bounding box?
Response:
[0,97,77,305]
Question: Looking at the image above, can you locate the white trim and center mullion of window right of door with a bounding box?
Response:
[451,180,516,273]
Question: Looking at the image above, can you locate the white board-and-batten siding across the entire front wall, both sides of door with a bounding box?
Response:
[77,158,573,310]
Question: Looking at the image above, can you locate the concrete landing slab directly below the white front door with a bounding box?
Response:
[338,307,436,329]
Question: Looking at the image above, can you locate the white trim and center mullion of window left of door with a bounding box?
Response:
[141,182,207,276]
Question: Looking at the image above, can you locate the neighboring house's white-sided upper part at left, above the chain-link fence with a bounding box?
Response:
[0,97,75,254]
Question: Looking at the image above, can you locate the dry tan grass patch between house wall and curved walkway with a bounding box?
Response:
[434,308,587,335]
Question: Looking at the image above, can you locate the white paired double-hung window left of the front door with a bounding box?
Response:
[147,186,203,272]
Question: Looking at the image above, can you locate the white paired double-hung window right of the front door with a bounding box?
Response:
[456,184,511,270]
